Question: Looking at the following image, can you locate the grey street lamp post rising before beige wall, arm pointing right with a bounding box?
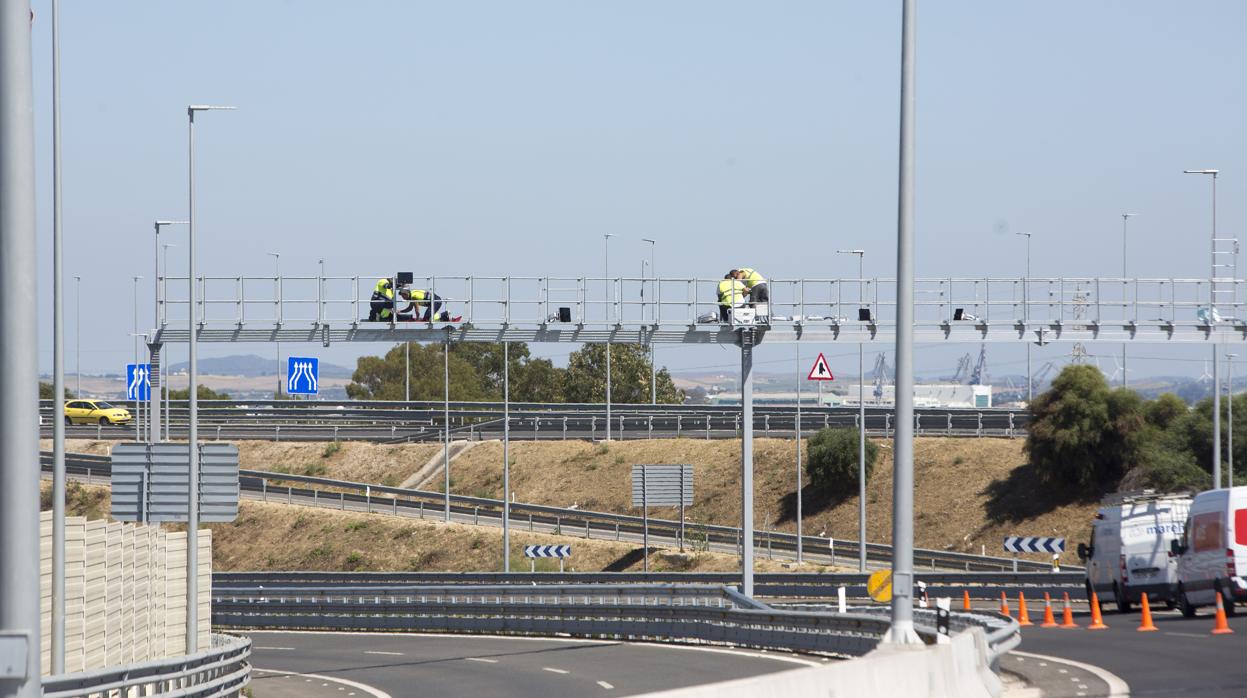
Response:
[186,105,237,654]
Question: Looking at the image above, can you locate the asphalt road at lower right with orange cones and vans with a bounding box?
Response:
[1003,603,1247,698]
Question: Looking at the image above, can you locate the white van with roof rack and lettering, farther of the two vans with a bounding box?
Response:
[1079,490,1191,613]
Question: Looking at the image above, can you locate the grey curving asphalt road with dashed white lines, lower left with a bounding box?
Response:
[248,632,818,698]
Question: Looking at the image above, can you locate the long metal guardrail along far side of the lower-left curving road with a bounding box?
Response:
[213,585,897,657]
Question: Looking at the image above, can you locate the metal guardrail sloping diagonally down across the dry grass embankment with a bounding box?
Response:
[40,451,1079,572]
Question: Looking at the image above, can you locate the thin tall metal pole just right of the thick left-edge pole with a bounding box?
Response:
[51,0,65,674]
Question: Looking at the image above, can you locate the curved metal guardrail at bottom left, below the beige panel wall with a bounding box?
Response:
[42,633,251,698]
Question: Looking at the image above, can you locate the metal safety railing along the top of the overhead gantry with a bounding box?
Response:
[158,273,1247,329]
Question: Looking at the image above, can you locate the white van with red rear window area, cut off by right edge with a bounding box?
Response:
[1173,487,1247,617]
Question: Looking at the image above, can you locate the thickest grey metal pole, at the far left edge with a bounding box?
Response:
[0,0,42,698]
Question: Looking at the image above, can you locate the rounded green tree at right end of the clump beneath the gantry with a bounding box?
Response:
[564,344,685,404]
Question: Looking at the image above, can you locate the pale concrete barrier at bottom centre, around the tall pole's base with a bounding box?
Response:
[648,628,1003,698]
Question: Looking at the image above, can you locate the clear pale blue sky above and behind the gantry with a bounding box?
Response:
[35,0,1247,375]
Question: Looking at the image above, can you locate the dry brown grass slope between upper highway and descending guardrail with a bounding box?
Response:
[45,437,1100,565]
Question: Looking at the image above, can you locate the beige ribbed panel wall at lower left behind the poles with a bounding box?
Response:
[40,511,212,676]
